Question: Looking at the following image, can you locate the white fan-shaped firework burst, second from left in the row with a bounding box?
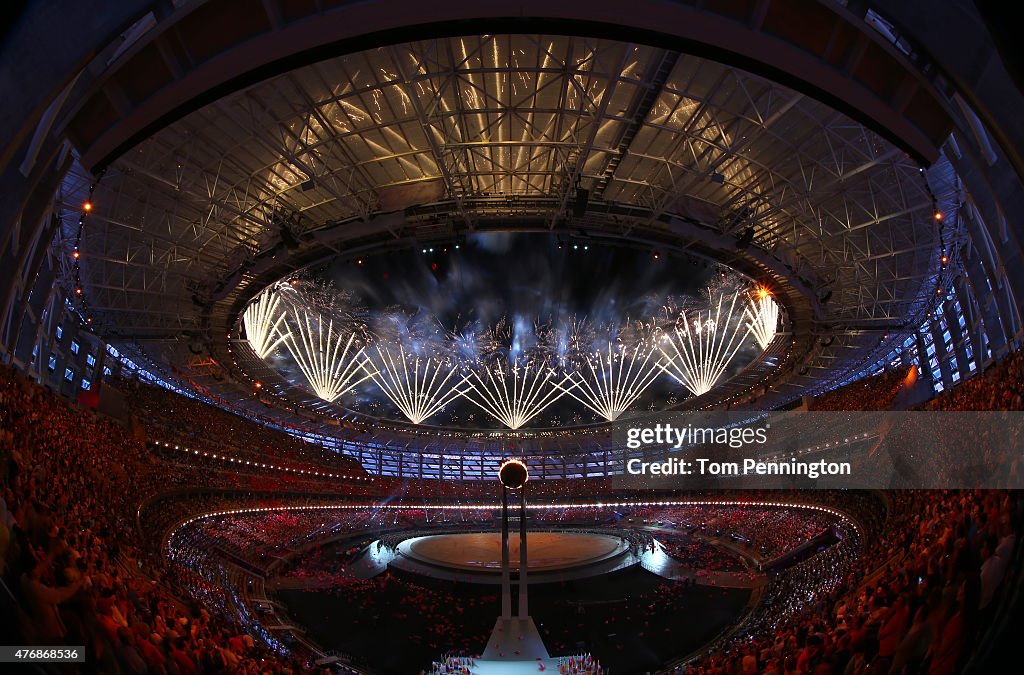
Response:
[285,312,373,403]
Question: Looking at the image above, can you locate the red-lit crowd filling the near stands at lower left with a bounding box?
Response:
[0,367,323,675]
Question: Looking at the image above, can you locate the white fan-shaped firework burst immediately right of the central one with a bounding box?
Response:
[565,343,662,422]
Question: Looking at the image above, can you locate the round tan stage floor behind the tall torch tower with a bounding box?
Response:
[398,532,629,574]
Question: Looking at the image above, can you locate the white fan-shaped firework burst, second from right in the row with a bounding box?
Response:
[658,294,750,396]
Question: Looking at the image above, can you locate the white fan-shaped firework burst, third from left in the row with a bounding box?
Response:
[364,344,467,424]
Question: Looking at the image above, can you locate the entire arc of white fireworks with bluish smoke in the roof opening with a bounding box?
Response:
[249,259,781,422]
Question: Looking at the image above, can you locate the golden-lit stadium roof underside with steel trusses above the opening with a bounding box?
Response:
[55,35,957,417]
